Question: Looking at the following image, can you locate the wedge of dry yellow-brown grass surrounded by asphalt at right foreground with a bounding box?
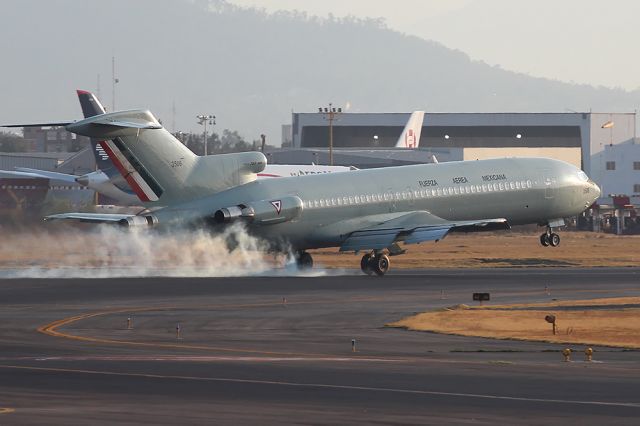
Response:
[388,297,640,349]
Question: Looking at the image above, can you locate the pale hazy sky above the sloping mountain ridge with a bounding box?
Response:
[229,0,640,90]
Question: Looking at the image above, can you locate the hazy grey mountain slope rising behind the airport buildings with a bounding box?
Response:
[0,0,640,143]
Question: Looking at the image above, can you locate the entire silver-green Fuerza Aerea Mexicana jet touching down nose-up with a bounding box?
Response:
[1,103,600,276]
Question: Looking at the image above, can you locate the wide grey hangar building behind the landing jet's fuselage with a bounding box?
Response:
[268,112,640,196]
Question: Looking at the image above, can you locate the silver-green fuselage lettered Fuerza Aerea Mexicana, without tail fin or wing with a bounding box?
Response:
[154,158,599,250]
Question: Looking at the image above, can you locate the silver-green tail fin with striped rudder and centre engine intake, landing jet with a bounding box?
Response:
[66,110,266,205]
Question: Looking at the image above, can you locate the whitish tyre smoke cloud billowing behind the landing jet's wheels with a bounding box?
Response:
[0,225,321,278]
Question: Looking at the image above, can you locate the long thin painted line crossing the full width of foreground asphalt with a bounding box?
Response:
[0,365,640,409]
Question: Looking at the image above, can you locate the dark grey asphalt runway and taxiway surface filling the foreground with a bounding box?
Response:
[0,269,640,425]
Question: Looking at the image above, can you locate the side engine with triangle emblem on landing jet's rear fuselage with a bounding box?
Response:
[213,195,303,225]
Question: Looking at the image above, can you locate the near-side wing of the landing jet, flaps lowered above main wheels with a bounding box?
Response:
[340,211,510,251]
